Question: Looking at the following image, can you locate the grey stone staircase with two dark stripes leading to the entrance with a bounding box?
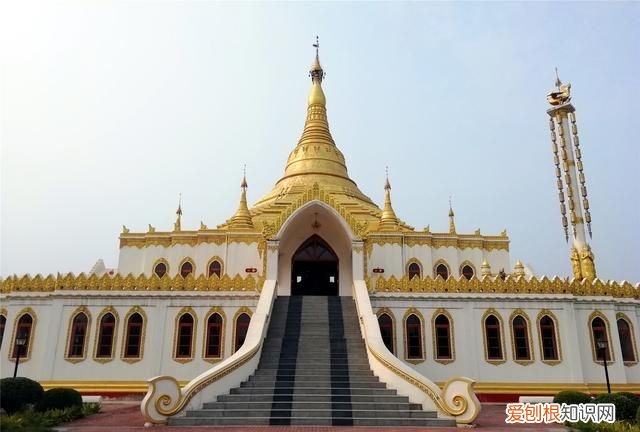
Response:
[169,296,455,427]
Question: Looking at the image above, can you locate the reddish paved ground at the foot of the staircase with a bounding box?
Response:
[56,401,567,432]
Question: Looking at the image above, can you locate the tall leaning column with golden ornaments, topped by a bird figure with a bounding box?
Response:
[547,70,596,280]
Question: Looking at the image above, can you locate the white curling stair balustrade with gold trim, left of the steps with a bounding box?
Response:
[140,280,276,426]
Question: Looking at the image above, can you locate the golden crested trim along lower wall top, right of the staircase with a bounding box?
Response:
[366,275,640,299]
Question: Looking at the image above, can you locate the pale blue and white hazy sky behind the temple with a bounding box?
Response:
[0,2,640,282]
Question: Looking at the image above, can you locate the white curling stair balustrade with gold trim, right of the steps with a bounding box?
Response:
[353,280,481,426]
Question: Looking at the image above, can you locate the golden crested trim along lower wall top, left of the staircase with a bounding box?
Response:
[0,273,264,294]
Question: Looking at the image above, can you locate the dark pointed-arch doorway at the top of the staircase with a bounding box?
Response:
[291,234,338,296]
